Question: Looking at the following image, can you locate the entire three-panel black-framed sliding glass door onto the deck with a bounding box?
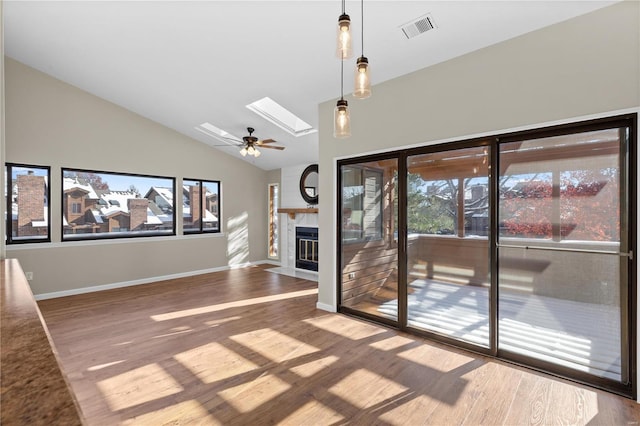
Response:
[337,114,637,395]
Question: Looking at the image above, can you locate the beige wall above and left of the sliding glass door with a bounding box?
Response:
[318,1,640,309]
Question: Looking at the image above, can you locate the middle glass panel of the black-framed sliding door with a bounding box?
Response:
[406,146,491,347]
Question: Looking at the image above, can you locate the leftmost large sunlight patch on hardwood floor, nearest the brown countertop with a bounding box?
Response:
[97,363,184,411]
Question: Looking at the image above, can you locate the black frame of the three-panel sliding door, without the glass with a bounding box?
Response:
[336,113,638,399]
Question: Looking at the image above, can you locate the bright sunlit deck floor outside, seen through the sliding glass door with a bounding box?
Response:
[379,279,621,381]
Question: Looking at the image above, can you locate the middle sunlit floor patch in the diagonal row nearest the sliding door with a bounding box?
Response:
[329,368,408,409]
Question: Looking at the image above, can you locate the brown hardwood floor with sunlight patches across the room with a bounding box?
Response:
[39,267,640,425]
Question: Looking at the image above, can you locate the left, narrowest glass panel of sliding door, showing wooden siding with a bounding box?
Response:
[340,159,398,322]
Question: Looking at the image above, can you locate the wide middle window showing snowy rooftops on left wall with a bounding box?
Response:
[62,169,175,241]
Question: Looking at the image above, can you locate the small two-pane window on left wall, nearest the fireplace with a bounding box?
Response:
[182,179,220,234]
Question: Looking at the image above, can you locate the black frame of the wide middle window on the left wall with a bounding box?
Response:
[60,167,176,243]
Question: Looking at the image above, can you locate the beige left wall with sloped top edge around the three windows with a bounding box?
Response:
[5,58,269,295]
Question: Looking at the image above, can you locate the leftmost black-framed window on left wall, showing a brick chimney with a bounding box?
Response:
[5,163,51,244]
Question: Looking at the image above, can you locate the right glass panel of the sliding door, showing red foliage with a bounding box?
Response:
[498,127,629,383]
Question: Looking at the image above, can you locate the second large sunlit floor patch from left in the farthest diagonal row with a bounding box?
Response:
[173,342,258,384]
